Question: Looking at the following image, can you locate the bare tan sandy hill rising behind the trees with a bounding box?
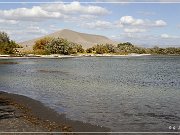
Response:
[19,29,116,50]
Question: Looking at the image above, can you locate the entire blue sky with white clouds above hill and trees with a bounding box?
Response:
[0,0,180,47]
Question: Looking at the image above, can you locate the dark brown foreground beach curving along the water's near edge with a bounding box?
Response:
[0,91,111,134]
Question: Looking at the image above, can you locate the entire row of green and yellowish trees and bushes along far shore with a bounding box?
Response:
[0,32,180,55]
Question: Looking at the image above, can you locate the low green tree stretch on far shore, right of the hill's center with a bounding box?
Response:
[86,42,180,55]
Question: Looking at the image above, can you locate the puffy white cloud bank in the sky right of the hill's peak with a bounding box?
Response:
[81,16,167,30]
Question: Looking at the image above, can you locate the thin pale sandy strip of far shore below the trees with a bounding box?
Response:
[0,53,151,59]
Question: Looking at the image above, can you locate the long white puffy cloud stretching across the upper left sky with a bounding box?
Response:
[0,2,110,21]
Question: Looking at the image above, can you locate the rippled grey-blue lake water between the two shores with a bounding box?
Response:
[0,56,180,131]
